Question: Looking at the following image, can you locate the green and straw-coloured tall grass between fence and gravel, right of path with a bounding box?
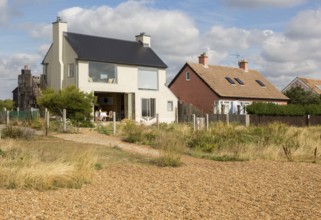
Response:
[117,122,321,162]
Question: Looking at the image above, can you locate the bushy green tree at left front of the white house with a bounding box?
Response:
[37,86,96,121]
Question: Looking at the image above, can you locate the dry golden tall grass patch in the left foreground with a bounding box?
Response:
[0,139,97,190]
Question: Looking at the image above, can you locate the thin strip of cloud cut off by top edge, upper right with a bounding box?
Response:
[222,0,307,8]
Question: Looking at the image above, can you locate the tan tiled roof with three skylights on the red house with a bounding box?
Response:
[187,63,288,100]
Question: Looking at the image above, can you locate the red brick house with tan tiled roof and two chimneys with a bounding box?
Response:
[169,53,288,114]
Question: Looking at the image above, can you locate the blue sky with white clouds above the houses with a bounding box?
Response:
[0,0,321,100]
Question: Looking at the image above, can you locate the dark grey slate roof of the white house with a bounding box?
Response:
[64,32,167,68]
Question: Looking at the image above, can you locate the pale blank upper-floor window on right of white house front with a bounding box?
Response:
[138,68,158,90]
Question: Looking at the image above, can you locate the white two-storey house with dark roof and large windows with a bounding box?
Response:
[42,17,177,123]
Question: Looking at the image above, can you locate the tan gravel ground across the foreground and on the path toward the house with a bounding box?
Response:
[0,129,321,219]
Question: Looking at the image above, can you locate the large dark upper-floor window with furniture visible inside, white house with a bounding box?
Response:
[88,62,117,83]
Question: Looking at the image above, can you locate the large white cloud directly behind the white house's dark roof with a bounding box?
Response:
[59,1,201,76]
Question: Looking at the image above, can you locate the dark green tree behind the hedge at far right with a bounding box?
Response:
[284,86,321,105]
